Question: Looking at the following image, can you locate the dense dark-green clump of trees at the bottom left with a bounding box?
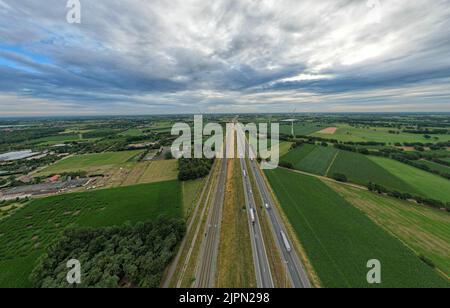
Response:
[30,218,185,288]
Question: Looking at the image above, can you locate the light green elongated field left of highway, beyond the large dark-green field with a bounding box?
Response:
[38,151,143,176]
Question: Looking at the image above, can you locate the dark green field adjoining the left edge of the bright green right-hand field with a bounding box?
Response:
[328,151,418,194]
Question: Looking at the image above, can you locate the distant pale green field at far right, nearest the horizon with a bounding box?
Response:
[313,125,450,143]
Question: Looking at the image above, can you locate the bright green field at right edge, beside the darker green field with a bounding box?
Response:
[370,157,450,202]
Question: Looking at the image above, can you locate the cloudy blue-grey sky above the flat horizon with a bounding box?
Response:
[0,0,450,116]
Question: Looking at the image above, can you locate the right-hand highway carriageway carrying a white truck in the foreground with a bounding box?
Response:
[238,124,311,288]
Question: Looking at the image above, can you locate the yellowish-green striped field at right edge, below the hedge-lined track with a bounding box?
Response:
[329,182,450,277]
